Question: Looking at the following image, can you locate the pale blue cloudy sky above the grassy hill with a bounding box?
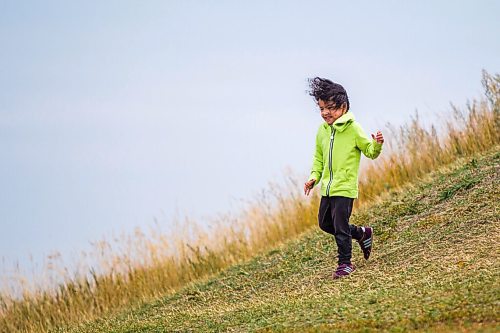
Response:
[0,0,500,280]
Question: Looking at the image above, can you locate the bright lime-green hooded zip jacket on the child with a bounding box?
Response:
[309,112,382,198]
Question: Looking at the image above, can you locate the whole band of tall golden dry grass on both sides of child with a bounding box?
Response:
[0,72,500,332]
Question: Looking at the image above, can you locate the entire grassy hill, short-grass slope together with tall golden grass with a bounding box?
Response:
[0,71,500,333]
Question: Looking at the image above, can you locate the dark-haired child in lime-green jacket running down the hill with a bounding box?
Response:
[304,77,384,279]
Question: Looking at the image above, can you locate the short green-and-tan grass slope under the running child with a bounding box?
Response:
[67,147,500,332]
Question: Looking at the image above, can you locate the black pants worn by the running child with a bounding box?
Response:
[318,196,363,265]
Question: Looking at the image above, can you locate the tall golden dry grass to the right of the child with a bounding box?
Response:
[358,71,500,204]
